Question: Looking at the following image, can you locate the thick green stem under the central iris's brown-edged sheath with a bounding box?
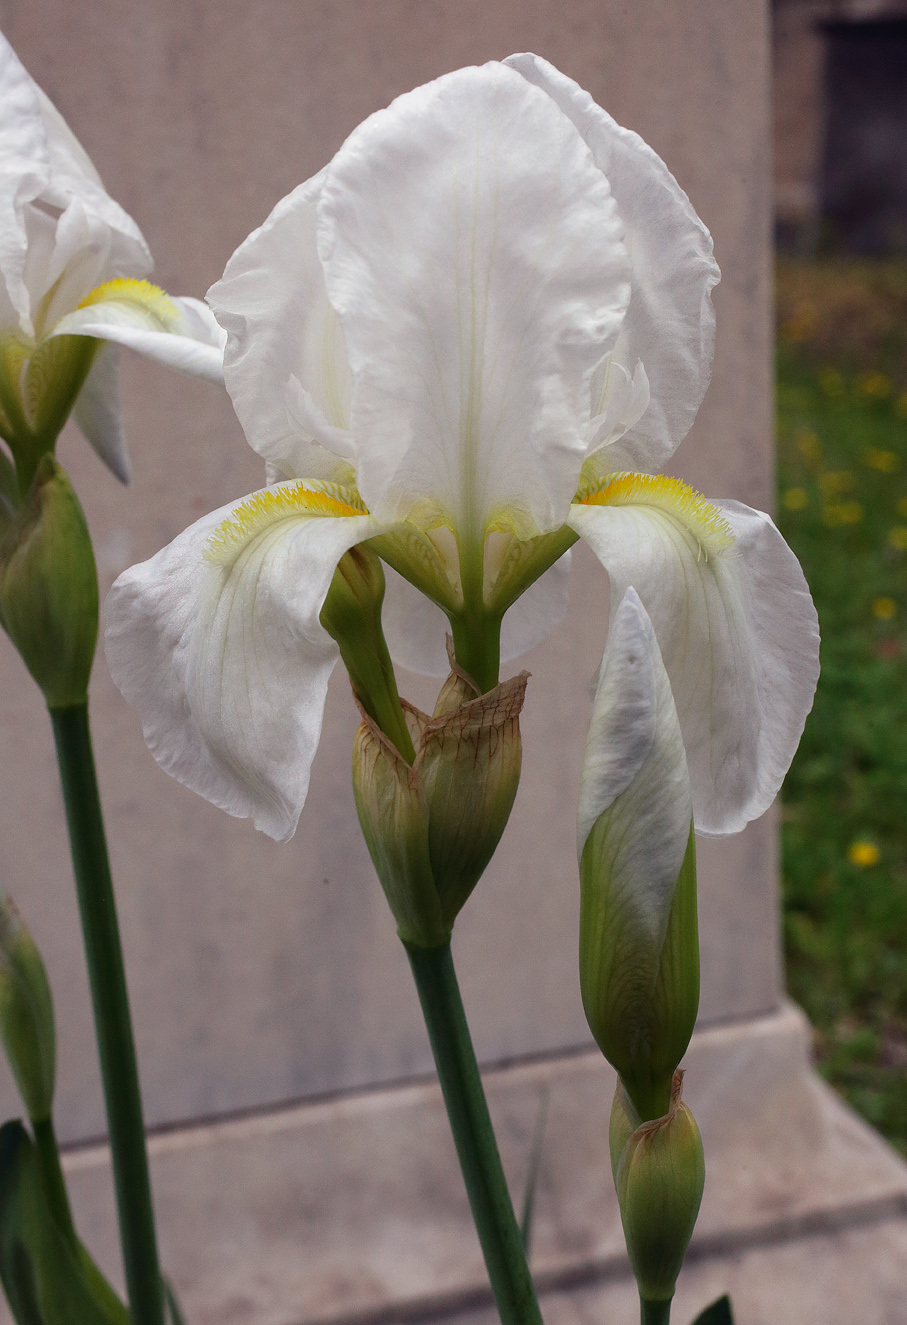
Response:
[404,943,542,1325]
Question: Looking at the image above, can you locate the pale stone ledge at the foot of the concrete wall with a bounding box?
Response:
[1,1004,907,1325]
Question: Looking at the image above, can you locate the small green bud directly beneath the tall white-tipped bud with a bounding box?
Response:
[616,1072,706,1302]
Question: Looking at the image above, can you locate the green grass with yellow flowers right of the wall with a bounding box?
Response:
[777,268,907,1154]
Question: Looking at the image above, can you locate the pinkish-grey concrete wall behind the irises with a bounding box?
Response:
[0,0,779,1140]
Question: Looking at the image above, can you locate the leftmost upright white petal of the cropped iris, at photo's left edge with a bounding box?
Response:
[0,33,50,333]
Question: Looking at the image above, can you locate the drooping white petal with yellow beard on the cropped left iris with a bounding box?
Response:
[50,278,225,384]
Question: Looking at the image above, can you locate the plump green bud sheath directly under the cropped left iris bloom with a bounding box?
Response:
[0,454,98,709]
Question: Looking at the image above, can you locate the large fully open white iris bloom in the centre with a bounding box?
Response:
[107,56,818,839]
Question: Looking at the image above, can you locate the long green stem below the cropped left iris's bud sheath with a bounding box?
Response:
[50,704,164,1325]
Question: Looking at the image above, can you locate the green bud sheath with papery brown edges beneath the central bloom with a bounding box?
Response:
[354,649,527,947]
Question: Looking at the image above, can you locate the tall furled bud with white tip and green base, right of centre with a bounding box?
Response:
[579,588,699,1120]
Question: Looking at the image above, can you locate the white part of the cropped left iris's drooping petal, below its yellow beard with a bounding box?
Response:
[50,297,224,384]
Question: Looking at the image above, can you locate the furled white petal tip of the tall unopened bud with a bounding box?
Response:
[577,588,692,957]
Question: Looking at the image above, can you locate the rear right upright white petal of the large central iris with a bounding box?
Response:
[506,54,719,470]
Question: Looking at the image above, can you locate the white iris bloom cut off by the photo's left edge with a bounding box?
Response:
[0,34,224,481]
